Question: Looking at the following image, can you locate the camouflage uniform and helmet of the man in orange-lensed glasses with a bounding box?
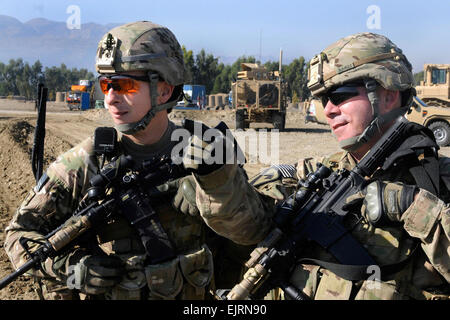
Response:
[5,22,265,299]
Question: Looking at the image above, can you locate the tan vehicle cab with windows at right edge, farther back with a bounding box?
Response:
[416,64,450,107]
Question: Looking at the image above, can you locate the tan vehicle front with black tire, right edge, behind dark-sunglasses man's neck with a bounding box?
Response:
[406,97,450,147]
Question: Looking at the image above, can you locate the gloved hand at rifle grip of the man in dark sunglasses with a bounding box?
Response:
[344,180,418,227]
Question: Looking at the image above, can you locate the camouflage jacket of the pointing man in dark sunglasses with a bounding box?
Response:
[197,129,450,299]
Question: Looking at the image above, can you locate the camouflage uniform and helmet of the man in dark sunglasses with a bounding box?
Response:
[197,33,450,299]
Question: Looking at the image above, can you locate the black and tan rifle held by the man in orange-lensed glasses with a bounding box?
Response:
[0,155,187,289]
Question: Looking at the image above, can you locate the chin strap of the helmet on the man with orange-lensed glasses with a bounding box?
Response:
[115,71,177,134]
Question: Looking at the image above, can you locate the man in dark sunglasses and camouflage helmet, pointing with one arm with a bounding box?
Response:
[190,33,450,300]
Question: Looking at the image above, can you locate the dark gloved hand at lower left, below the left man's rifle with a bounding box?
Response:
[68,255,125,295]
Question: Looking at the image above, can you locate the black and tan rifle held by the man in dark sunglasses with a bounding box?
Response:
[227,117,408,300]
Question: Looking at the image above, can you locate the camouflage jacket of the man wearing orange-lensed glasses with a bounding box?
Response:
[5,122,260,299]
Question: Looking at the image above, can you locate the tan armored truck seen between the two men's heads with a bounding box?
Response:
[231,55,287,131]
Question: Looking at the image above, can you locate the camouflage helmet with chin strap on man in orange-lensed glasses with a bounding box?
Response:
[95,21,186,134]
